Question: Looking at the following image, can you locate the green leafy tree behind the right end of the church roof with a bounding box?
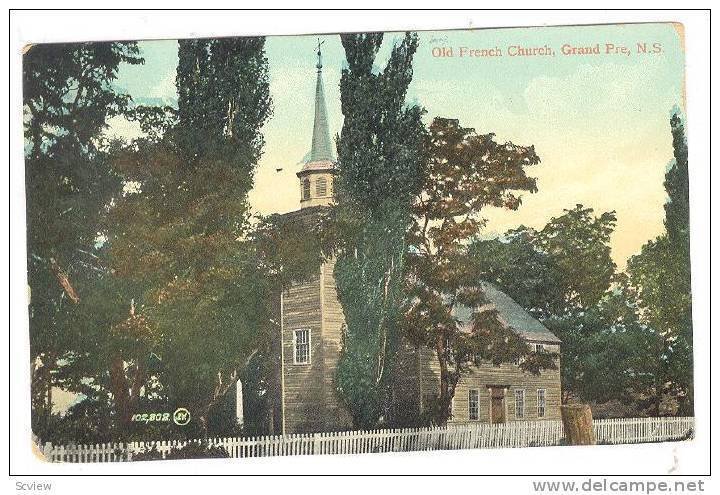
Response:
[470,205,620,402]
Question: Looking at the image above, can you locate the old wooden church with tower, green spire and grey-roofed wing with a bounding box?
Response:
[272,48,560,434]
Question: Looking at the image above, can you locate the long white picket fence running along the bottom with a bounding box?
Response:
[38,417,694,462]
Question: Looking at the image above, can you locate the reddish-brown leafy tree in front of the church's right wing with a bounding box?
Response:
[403,118,555,424]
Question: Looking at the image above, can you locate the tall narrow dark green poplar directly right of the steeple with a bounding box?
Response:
[335,33,425,428]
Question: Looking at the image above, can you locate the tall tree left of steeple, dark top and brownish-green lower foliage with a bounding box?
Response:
[107,38,273,434]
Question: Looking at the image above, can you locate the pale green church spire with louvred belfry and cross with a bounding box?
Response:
[297,39,335,208]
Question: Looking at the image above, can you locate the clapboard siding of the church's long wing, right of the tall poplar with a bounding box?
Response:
[420,344,561,422]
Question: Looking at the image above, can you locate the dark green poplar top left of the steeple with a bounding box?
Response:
[176,37,272,170]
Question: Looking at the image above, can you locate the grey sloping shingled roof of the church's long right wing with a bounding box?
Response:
[453,282,561,344]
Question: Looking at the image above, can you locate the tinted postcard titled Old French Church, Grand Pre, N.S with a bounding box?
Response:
[23,23,695,462]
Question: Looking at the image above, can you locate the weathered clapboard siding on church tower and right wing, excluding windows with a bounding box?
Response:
[282,222,561,434]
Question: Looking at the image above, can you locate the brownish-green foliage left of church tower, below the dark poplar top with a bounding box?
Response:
[107,139,272,433]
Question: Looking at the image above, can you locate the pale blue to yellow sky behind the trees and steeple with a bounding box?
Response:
[109,24,684,268]
